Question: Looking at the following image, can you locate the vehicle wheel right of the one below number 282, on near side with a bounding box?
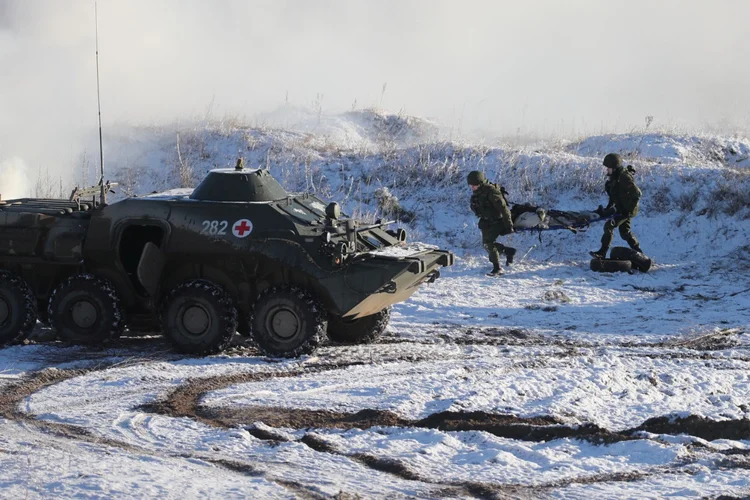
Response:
[249,286,328,357]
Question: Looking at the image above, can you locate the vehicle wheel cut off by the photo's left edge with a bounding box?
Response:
[0,271,37,345]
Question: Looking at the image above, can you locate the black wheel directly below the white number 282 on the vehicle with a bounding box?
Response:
[161,280,237,354]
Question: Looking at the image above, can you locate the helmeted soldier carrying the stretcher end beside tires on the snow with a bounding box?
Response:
[589,153,641,259]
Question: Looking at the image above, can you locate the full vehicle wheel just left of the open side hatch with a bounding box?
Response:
[47,274,125,344]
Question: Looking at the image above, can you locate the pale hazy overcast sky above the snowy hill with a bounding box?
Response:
[0,0,750,192]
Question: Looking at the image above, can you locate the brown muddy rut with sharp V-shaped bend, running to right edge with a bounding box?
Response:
[141,362,750,444]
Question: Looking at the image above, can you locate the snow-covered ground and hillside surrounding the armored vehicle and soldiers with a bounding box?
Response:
[0,114,750,498]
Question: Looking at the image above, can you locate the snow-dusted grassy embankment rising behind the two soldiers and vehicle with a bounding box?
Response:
[105,108,750,263]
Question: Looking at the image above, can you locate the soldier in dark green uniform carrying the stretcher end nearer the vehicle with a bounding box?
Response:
[466,170,516,276]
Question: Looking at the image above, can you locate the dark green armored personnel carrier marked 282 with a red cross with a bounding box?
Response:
[0,161,454,357]
